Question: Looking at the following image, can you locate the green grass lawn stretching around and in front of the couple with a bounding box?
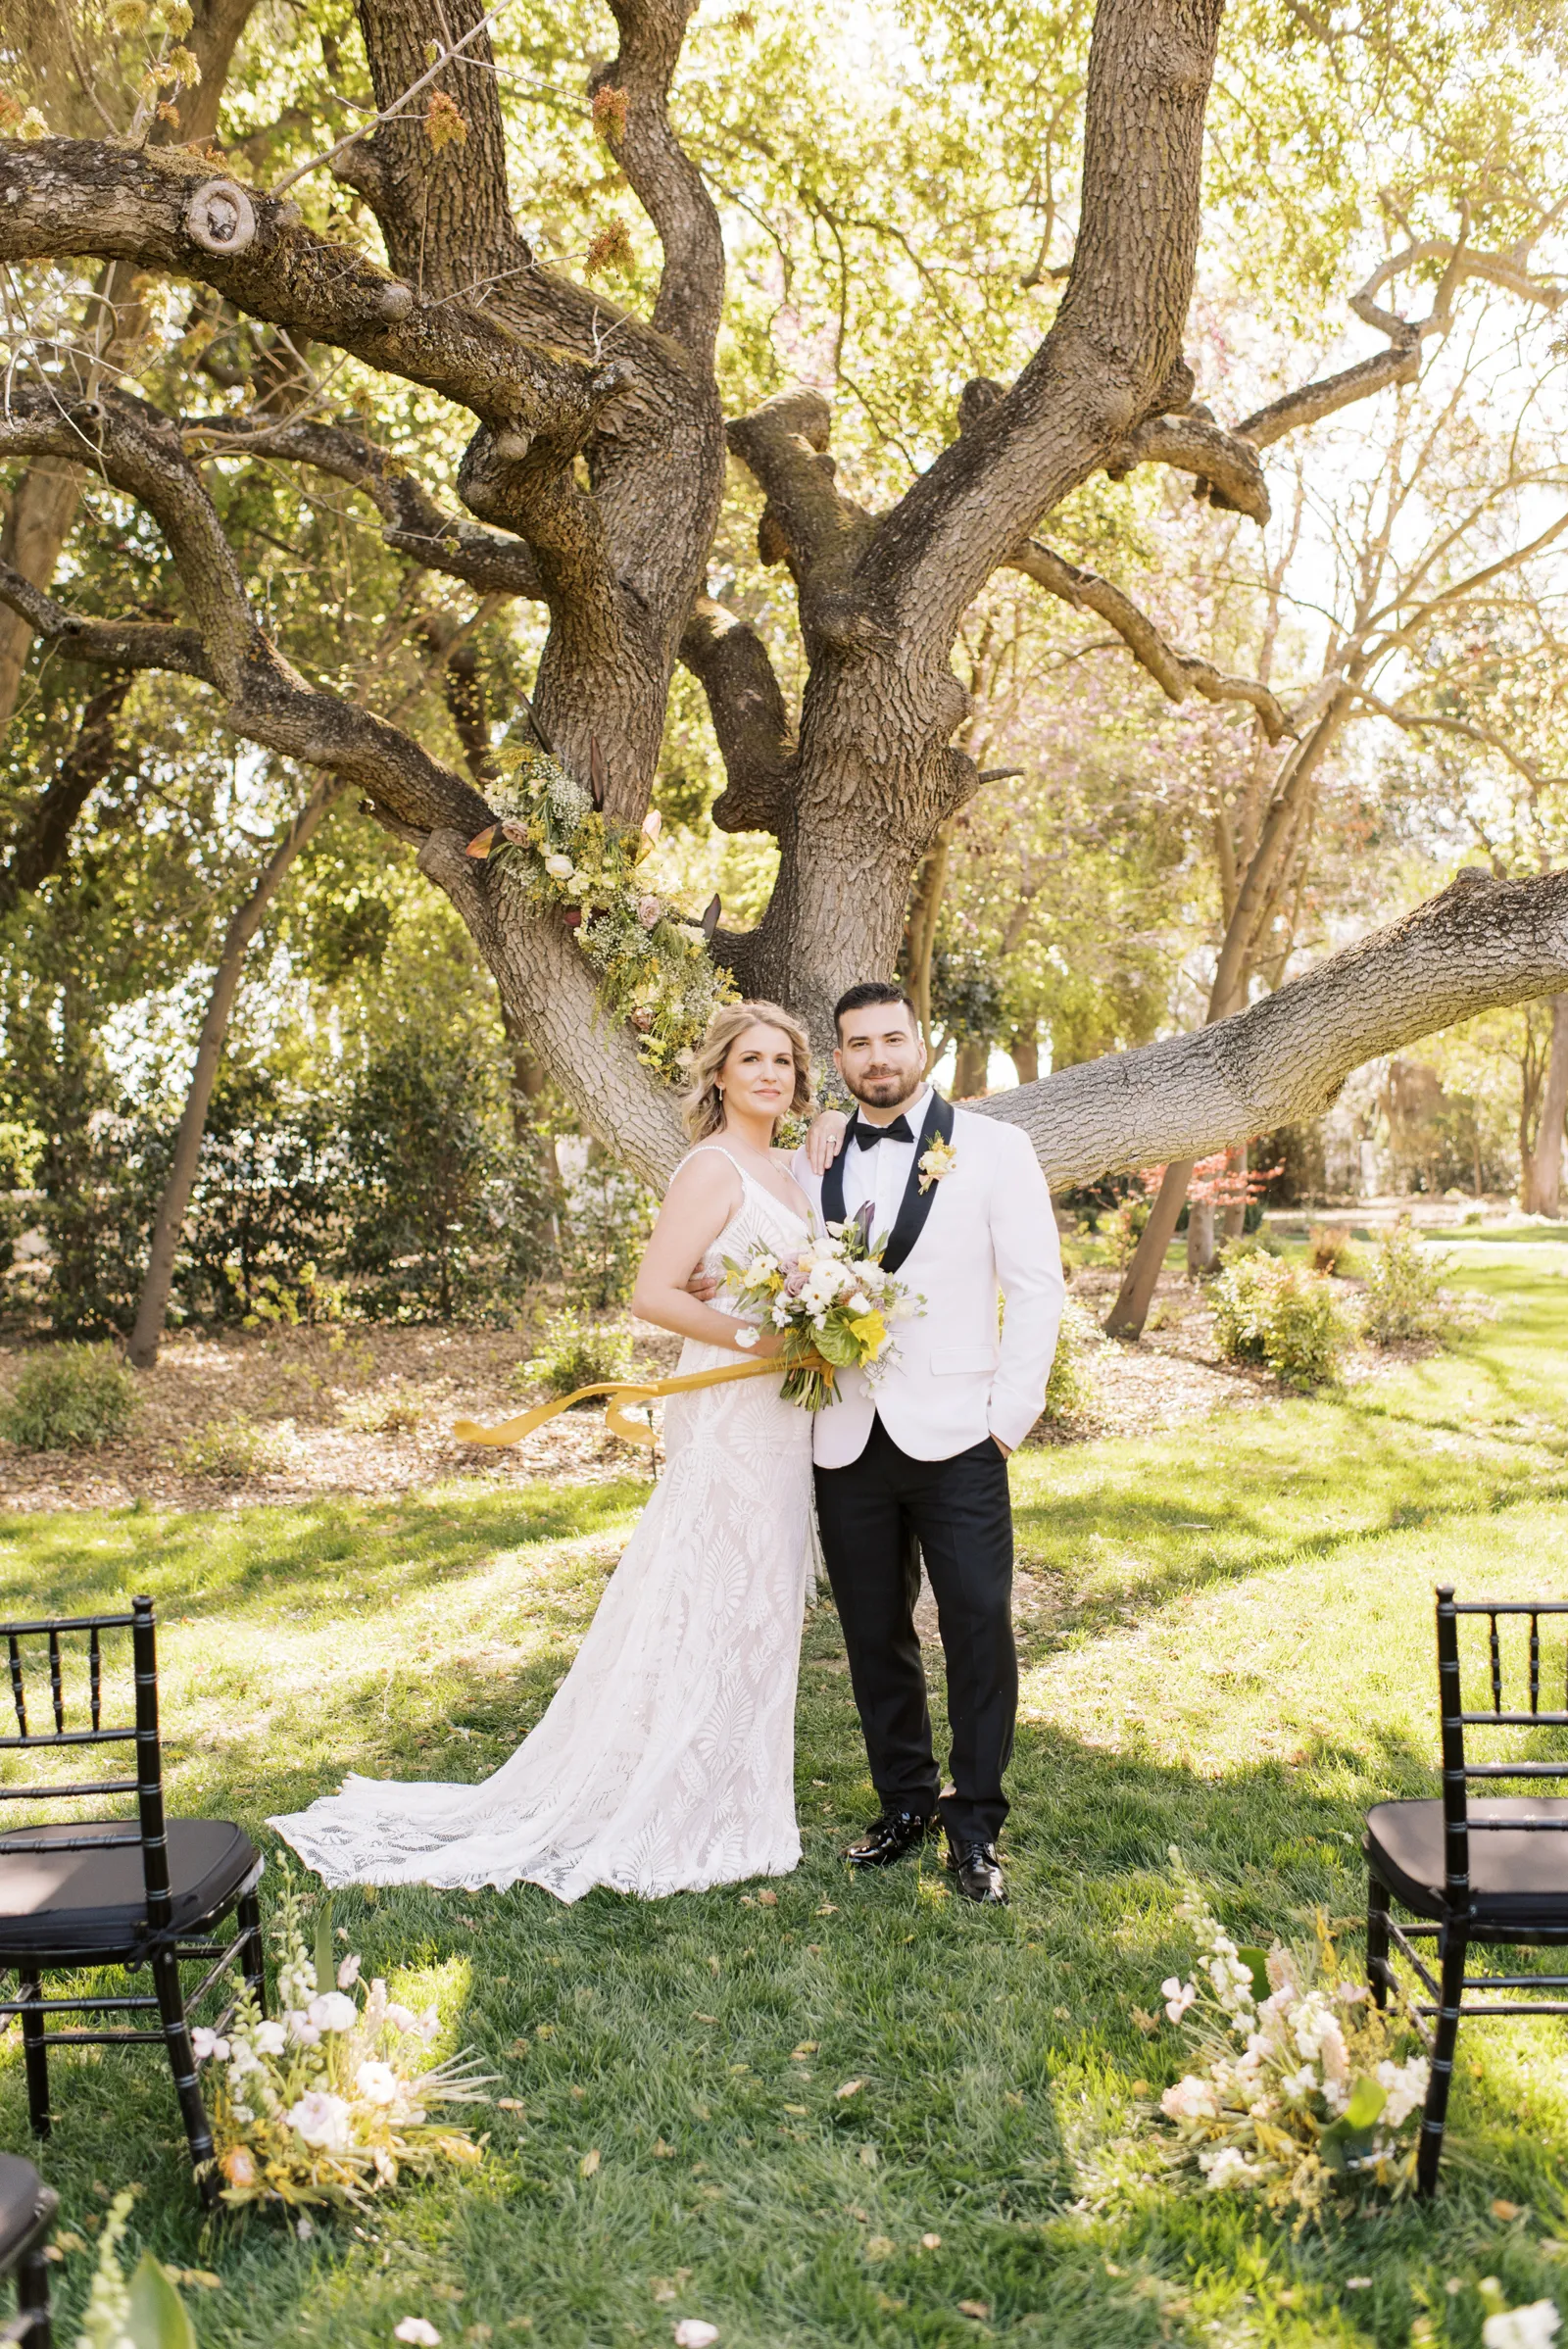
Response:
[0,1233,1568,2349]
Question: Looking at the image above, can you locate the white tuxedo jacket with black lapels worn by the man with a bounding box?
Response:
[794,1095,1063,1468]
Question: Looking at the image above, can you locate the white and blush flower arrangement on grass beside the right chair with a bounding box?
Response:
[1159,1844,1430,2229]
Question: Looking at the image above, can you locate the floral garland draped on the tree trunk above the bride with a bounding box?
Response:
[467,745,737,1083]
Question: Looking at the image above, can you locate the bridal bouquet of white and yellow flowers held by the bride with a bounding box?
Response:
[725,1212,920,1412]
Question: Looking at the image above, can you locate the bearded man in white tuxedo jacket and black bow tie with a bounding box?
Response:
[794,982,1063,1903]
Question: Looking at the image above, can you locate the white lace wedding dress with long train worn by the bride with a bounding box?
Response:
[270,1144,814,1900]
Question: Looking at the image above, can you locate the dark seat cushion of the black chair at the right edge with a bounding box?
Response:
[1364,1794,1568,1927]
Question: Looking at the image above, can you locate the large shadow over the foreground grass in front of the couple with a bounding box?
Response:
[0,1690,1568,2349]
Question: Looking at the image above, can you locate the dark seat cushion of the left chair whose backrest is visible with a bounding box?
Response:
[0,1818,256,1964]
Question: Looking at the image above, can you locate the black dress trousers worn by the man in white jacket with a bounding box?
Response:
[817,1419,1019,1846]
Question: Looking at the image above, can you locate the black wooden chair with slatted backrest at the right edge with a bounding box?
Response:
[1361,1584,1568,2194]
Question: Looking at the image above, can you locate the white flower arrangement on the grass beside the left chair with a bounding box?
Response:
[192,1870,495,2208]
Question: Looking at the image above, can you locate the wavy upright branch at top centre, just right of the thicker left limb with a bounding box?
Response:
[589,0,723,368]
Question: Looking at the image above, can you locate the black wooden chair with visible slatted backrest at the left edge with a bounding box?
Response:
[0,1597,263,2201]
